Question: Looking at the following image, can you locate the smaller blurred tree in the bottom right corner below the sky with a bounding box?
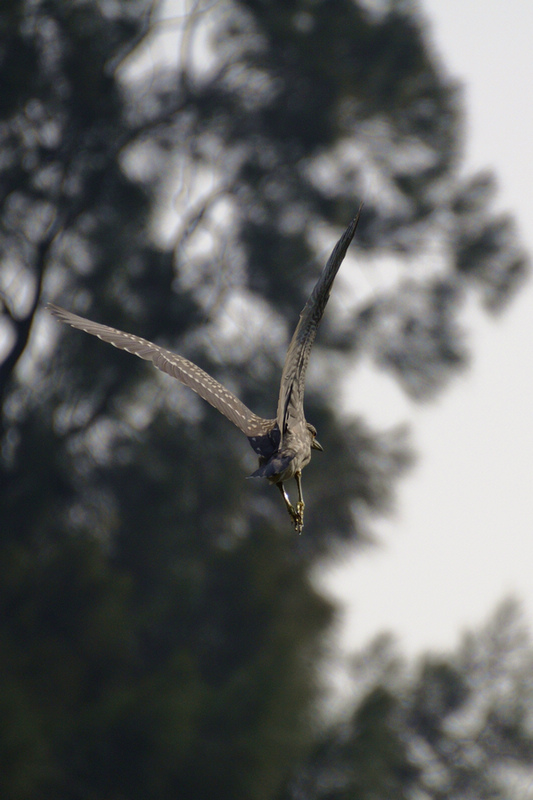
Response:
[280,601,533,800]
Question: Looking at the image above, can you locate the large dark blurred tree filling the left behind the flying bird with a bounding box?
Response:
[0,0,525,800]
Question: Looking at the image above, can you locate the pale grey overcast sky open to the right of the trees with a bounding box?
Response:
[320,0,533,654]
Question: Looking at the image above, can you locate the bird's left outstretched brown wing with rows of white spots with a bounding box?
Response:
[47,303,276,436]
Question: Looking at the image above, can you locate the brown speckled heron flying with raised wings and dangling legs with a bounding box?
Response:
[47,209,361,533]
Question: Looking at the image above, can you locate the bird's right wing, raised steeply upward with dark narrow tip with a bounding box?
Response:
[277,206,362,436]
